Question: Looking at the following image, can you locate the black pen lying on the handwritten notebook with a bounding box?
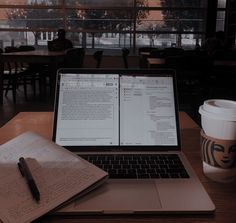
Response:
[18,157,40,201]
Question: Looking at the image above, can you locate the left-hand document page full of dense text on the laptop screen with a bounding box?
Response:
[56,74,119,146]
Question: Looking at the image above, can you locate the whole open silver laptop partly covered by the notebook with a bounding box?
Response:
[53,69,215,214]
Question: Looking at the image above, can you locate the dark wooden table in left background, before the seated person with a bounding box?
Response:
[0,50,65,105]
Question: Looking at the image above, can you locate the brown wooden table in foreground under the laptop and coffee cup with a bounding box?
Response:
[0,112,236,223]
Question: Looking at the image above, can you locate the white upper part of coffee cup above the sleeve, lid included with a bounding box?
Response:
[199,99,236,140]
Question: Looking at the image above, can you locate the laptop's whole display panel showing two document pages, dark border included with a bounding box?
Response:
[53,70,181,152]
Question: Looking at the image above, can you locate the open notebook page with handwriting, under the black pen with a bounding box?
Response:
[0,132,107,223]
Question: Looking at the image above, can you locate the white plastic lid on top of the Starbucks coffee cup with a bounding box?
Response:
[199,99,236,121]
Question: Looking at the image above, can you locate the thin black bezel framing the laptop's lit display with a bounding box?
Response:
[52,68,181,152]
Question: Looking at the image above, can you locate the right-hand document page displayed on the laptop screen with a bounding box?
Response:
[120,76,177,145]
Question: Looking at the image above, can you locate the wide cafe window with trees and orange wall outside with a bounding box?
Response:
[0,0,207,48]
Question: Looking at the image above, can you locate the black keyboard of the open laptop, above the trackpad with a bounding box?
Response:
[80,154,189,179]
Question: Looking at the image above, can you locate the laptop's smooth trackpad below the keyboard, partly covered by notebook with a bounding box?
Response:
[71,180,161,213]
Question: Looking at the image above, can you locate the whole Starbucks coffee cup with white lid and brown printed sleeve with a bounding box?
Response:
[199,99,236,182]
